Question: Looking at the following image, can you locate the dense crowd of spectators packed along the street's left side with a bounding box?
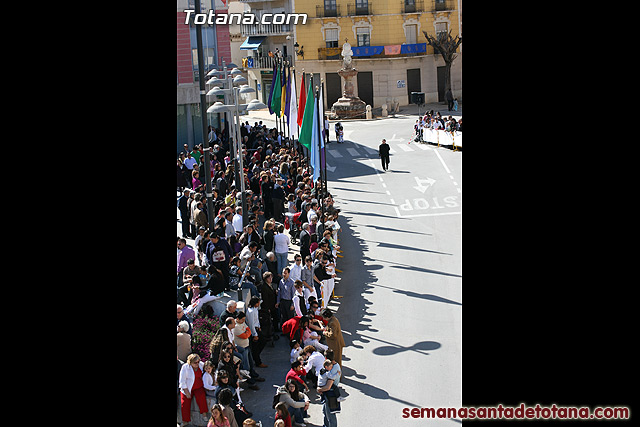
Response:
[176,122,345,427]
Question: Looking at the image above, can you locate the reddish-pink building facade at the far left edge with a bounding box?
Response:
[176,0,231,152]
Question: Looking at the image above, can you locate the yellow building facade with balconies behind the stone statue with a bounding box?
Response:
[293,0,462,109]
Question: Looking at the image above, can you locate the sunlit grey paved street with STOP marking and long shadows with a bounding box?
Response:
[327,116,462,426]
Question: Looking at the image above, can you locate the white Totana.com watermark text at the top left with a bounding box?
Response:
[184,9,307,25]
